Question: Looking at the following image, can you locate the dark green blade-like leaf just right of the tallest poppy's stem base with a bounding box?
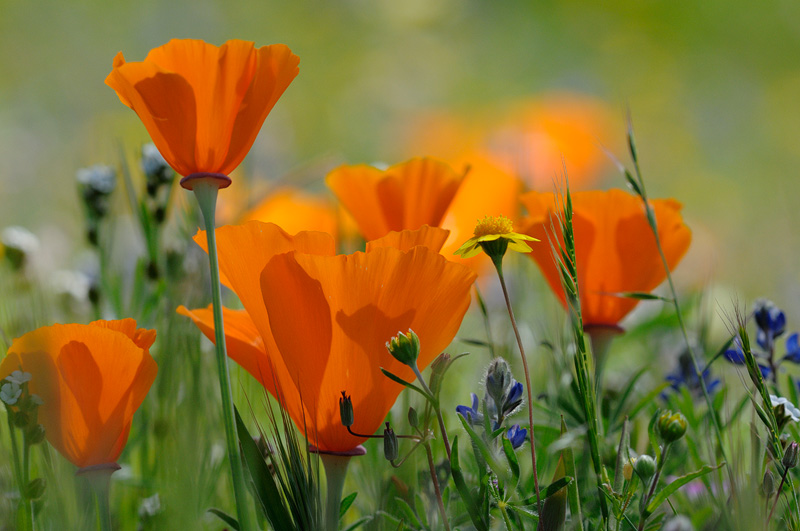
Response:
[234,407,295,529]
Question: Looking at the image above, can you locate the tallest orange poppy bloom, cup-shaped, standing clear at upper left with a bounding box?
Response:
[106,39,300,177]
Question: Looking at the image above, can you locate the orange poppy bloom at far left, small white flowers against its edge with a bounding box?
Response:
[0,319,158,468]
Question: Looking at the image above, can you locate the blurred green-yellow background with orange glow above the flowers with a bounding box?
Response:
[0,0,800,304]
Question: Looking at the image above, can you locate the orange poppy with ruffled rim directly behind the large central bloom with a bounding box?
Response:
[326,158,464,240]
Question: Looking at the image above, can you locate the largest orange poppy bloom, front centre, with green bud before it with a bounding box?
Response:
[178,222,475,452]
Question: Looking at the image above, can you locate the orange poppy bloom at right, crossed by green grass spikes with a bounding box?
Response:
[521,190,692,328]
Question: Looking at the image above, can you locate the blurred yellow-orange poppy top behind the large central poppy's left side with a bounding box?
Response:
[241,187,337,234]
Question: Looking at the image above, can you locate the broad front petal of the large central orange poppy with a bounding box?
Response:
[261,246,475,451]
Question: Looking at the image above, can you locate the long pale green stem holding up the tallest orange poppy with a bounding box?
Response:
[193,179,255,531]
